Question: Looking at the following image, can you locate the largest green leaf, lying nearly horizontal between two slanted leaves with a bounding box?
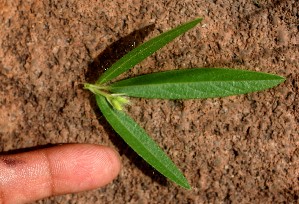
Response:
[109,68,284,99]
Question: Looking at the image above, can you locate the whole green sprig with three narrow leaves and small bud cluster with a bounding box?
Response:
[84,18,285,189]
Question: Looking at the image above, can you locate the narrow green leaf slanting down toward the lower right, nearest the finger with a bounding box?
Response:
[96,95,190,189]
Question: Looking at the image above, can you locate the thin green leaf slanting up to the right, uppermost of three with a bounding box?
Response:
[97,18,202,84]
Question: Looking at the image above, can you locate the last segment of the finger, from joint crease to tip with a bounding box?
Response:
[48,144,121,194]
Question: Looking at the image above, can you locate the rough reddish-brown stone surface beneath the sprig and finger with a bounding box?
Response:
[0,0,299,203]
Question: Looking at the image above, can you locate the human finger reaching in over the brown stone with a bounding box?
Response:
[0,144,121,204]
